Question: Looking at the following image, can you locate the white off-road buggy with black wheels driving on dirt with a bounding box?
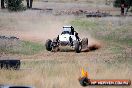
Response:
[45,26,88,53]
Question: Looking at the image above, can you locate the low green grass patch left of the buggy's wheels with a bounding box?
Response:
[0,41,45,55]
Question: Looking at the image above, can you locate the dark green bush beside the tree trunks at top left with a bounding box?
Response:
[5,0,25,11]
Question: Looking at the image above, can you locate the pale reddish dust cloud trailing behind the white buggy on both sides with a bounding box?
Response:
[0,13,101,50]
